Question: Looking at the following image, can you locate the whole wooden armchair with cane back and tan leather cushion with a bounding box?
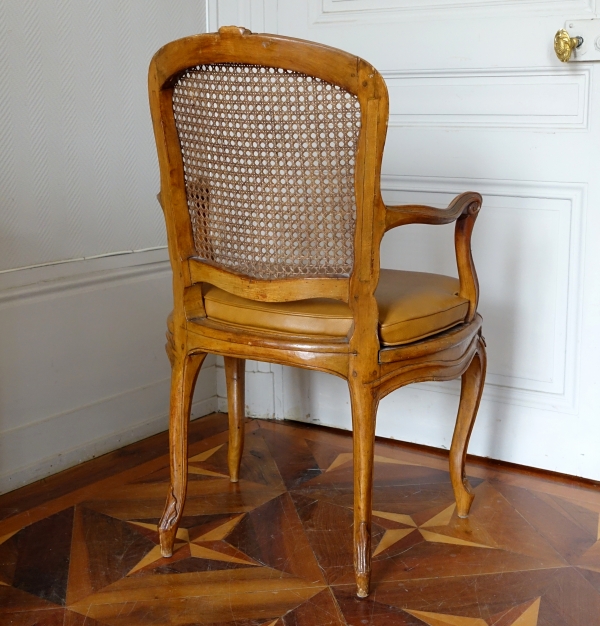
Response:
[149,27,485,597]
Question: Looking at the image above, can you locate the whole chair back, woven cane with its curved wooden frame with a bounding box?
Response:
[149,28,387,324]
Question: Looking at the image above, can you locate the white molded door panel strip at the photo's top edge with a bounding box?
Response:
[310,0,596,24]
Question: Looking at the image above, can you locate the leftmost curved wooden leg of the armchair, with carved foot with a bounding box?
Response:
[158,354,206,557]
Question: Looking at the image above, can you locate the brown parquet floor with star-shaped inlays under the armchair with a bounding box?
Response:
[0,414,600,626]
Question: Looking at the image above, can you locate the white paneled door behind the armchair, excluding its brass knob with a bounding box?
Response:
[208,0,600,479]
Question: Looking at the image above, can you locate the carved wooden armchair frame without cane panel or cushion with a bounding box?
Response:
[149,27,486,597]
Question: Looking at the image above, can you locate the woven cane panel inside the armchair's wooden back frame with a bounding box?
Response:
[173,64,360,279]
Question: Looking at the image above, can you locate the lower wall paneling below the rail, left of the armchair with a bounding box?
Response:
[0,250,217,493]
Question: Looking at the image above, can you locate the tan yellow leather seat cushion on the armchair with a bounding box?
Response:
[203,269,469,346]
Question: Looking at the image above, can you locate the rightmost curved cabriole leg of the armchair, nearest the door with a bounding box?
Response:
[450,337,487,517]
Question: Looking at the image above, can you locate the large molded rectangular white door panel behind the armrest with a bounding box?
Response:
[381,176,587,412]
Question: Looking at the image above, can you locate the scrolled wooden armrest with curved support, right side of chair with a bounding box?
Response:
[385,191,482,322]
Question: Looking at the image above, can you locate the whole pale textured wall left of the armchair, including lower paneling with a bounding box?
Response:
[0,0,217,492]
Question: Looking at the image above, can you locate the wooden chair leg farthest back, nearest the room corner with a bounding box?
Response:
[224,356,246,483]
